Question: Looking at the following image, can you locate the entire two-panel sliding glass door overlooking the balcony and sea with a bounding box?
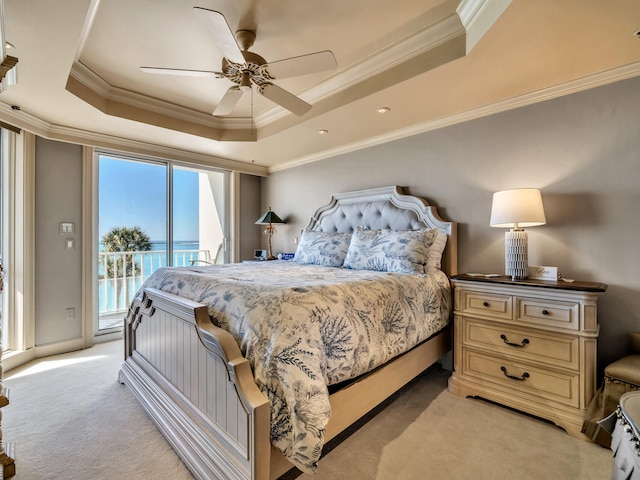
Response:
[96,153,228,334]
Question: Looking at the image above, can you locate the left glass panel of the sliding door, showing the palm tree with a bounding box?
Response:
[98,155,168,332]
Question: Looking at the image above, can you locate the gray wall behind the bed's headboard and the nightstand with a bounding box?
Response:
[262,74,640,372]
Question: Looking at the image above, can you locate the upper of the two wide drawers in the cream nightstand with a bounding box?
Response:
[462,319,580,370]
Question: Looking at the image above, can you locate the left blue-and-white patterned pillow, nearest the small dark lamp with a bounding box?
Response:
[293,230,351,267]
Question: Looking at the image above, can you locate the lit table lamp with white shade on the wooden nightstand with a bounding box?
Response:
[490,188,547,280]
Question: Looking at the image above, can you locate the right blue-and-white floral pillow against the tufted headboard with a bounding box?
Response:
[344,227,446,273]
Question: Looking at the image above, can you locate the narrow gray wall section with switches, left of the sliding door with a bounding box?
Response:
[35,138,82,346]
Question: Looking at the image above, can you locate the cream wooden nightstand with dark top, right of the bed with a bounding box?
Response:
[449,275,607,439]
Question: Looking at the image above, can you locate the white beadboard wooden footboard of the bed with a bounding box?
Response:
[120,289,271,480]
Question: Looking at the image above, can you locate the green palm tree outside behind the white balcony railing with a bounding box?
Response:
[102,226,151,278]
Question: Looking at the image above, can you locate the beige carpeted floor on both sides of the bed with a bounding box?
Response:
[2,342,613,480]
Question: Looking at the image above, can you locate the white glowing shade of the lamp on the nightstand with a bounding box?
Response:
[489,188,547,228]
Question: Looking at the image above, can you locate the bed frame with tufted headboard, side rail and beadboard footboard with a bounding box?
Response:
[119,186,457,480]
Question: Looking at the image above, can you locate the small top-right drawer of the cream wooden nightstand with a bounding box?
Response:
[515,297,580,330]
